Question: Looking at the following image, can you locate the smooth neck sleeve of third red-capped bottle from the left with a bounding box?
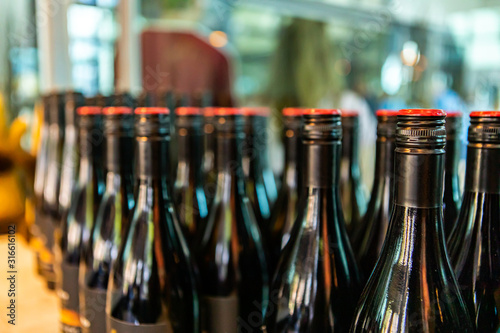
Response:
[136,136,170,183]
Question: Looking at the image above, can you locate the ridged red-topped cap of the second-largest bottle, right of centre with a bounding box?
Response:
[302,109,342,141]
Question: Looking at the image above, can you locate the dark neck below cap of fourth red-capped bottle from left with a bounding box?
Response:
[177,128,203,186]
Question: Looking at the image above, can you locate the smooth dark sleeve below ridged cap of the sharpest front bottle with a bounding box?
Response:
[394,147,444,208]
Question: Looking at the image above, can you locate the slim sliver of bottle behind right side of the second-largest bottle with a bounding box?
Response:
[340,110,366,236]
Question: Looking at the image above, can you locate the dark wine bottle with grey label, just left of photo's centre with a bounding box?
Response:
[197,108,269,333]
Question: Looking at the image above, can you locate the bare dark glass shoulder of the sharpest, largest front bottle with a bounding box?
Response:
[352,206,473,332]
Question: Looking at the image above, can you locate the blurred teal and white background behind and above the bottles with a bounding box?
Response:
[0,0,500,233]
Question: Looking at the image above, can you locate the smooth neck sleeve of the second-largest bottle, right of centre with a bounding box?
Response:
[303,140,341,188]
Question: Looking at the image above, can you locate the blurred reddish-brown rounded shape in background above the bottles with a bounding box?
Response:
[141,29,233,106]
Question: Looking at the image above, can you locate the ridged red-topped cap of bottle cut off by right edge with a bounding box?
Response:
[468,111,500,144]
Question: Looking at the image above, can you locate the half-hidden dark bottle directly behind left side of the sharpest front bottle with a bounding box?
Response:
[353,110,398,281]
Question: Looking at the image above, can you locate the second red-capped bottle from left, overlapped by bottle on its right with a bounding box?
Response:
[80,106,134,333]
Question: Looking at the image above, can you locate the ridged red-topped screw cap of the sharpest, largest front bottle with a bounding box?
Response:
[396,109,446,149]
